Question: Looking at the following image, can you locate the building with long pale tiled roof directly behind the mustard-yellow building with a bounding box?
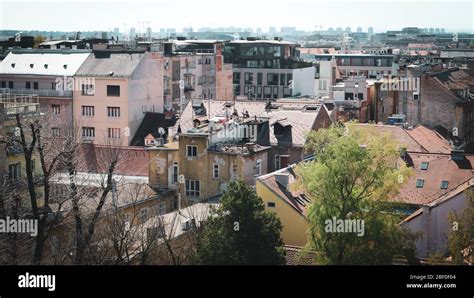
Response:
[174,98,332,171]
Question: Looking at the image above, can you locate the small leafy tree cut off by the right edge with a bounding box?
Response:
[448,190,474,265]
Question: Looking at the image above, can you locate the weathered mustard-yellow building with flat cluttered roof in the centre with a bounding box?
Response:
[147,116,271,205]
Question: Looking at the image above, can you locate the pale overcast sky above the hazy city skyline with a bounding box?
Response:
[0,0,474,32]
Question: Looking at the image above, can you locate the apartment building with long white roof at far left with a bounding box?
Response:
[0,49,91,133]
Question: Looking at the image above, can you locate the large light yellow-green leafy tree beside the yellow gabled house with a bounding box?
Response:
[293,122,415,264]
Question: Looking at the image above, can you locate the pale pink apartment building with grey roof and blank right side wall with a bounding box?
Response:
[73,50,164,146]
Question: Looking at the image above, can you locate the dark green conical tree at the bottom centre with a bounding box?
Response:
[194,181,285,265]
